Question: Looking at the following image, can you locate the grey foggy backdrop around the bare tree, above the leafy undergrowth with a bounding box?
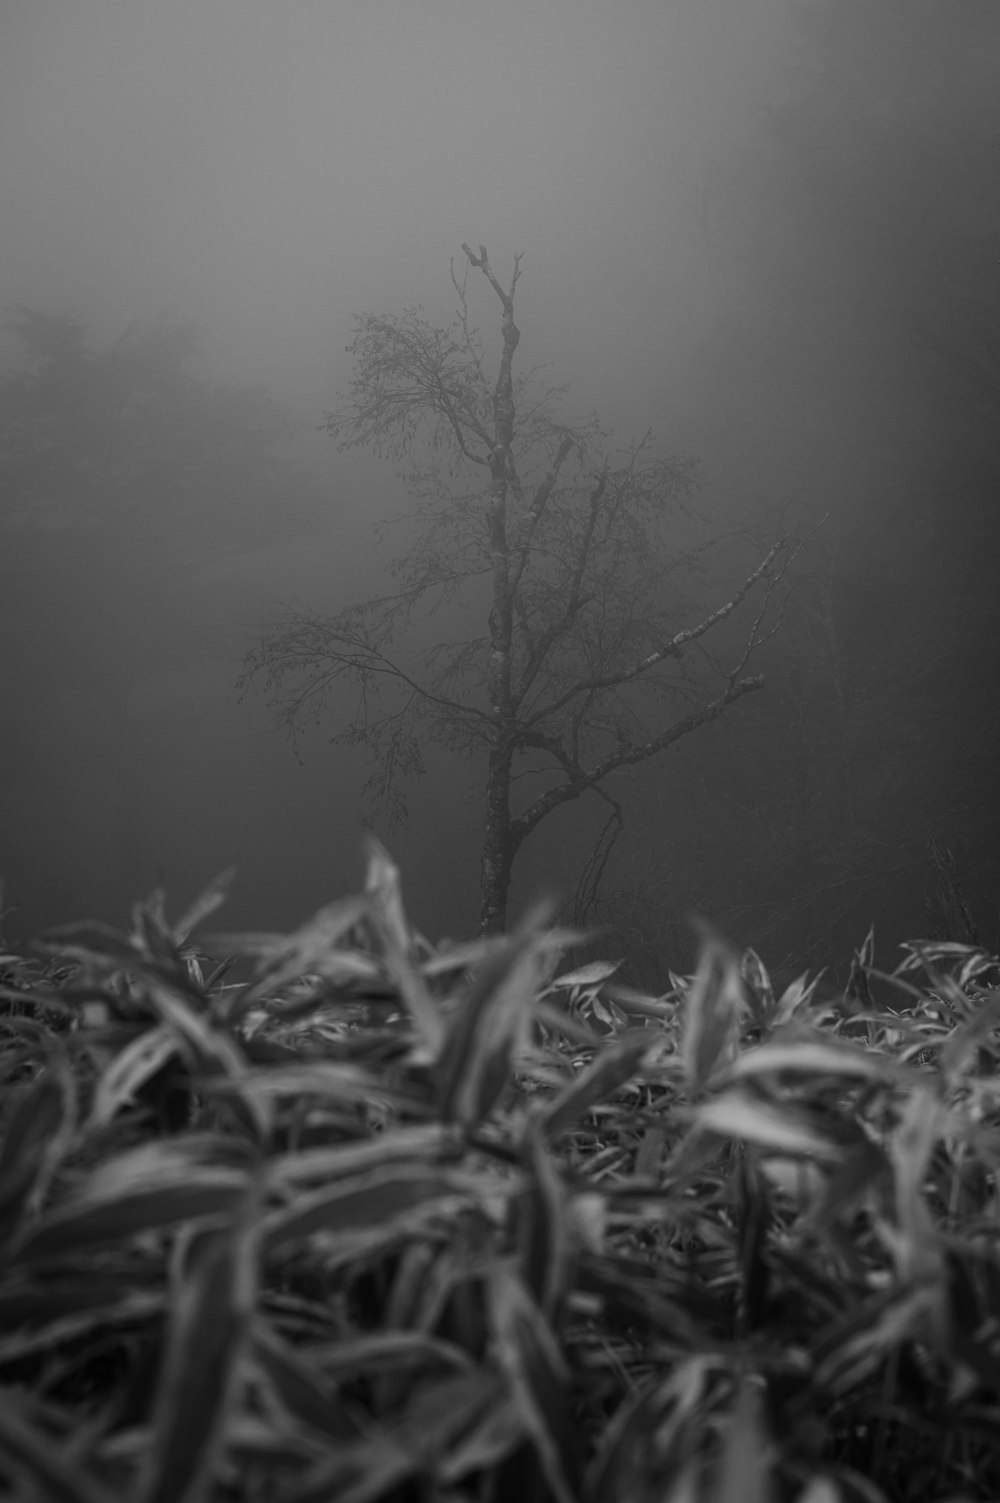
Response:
[0,0,1000,984]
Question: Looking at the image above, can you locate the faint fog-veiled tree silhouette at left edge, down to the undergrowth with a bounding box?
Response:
[0,308,321,924]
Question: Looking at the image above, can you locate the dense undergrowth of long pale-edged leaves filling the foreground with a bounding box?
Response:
[0,848,1000,1503]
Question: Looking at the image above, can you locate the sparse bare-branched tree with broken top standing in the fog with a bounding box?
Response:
[242,245,792,932]
